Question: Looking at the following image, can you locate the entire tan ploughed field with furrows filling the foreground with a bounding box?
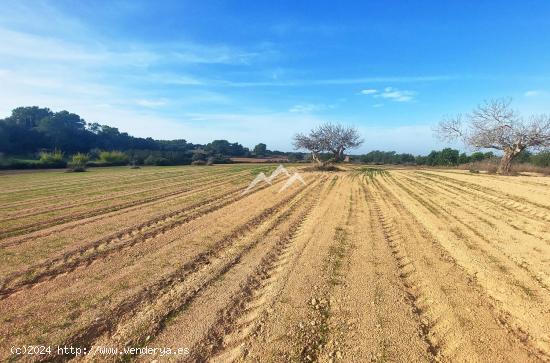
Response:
[0,165,550,362]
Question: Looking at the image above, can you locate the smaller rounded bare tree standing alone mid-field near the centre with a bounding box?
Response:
[294,123,363,164]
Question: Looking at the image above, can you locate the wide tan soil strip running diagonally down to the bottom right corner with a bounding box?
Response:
[379,175,544,361]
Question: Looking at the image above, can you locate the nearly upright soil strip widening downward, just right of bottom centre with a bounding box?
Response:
[321,177,433,362]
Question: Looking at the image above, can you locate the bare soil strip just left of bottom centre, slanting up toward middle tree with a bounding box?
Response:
[240,176,351,361]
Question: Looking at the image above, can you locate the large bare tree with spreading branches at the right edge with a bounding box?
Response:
[436,99,550,174]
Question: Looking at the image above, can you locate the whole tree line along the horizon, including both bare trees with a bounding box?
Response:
[0,105,550,168]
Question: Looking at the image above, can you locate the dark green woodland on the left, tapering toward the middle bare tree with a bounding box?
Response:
[0,106,303,168]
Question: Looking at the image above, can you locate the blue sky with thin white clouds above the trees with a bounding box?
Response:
[0,0,550,153]
